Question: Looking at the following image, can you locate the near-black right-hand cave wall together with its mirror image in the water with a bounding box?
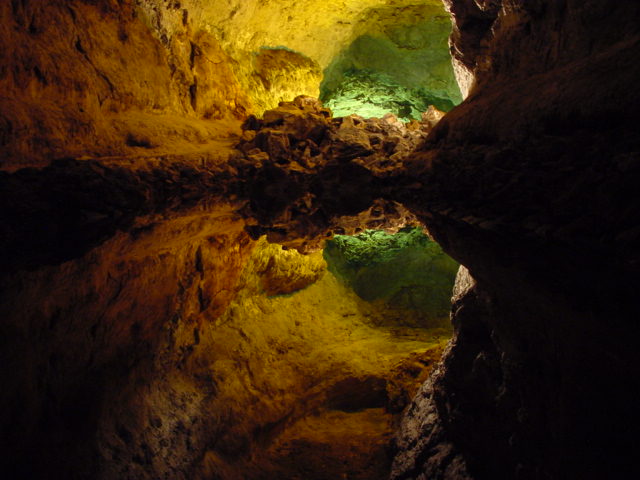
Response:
[392,1,640,479]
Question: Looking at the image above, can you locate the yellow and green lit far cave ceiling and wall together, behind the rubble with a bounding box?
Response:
[139,0,460,120]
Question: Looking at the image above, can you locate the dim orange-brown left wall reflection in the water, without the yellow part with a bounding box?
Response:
[0,205,253,478]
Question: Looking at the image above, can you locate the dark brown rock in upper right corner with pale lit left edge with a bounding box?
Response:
[443,0,637,96]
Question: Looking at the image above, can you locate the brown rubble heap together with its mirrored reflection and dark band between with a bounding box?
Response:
[238,96,442,251]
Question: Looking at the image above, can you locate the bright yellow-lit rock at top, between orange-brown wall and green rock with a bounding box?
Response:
[139,0,446,113]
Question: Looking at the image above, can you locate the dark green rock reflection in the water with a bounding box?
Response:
[324,228,458,324]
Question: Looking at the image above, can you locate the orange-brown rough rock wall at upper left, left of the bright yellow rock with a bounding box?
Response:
[0,0,247,168]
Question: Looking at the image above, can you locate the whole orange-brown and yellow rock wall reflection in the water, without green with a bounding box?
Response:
[0,213,446,480]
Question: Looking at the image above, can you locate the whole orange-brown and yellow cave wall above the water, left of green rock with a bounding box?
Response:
[0,0,448,170]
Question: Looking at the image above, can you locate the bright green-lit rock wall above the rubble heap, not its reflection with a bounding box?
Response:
[320,13,462,121]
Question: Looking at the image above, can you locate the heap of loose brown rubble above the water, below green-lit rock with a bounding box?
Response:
[238,96,444,174]
